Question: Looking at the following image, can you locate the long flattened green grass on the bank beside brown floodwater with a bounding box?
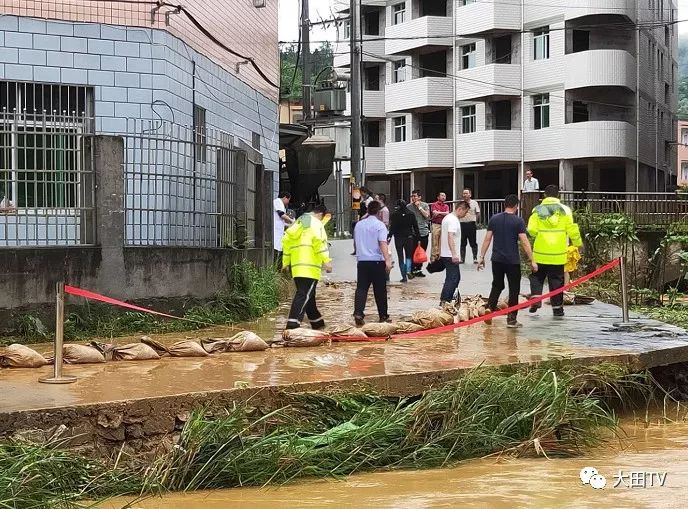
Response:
[0,363,668,509]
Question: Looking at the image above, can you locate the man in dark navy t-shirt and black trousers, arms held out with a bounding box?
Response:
[478,194,538,328]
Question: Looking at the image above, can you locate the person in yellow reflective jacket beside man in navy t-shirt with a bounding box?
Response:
[528,185,583,316]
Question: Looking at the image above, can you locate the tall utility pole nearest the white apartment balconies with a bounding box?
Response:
[349,0,365,187]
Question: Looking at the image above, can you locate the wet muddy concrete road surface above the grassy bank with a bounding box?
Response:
[0,241,688,440]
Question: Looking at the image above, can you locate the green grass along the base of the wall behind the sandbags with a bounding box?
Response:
[0,261,287,346]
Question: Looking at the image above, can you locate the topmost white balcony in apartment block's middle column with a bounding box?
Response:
[456,0,521,37]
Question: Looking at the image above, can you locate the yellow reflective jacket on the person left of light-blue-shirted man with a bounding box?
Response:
[282,214,332,280]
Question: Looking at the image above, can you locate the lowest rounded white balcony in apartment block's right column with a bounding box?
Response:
[525,120,636,161]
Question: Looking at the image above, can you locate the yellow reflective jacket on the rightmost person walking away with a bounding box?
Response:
[528,198,583,265]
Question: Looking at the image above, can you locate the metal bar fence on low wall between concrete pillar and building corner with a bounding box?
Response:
[125,119,251,248]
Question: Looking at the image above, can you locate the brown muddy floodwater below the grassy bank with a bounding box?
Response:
[101,420,688,509]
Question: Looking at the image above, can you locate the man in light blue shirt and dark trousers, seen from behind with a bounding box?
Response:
[354,201,392,327]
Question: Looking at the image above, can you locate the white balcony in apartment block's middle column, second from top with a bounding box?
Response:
[456,63,521,101]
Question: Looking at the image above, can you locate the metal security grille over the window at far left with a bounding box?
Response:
[0,108,96,248]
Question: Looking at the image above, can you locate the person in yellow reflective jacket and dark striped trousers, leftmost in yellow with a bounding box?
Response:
[282,205,332,329]
